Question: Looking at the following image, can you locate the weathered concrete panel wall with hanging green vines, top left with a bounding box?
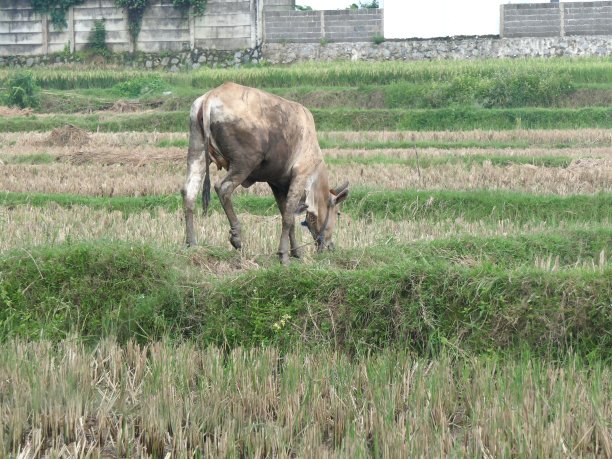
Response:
[0,0,295,56]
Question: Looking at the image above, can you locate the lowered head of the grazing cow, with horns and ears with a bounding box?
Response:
[297,182,349,252]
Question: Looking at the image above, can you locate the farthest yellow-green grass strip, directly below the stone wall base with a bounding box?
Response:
[0,58,612,90]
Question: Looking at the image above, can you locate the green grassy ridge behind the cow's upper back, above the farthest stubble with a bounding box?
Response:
[0,108,612,132]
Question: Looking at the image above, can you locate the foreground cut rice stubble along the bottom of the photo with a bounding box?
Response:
[0,340,612,458]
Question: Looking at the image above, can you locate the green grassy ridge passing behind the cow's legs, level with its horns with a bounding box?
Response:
[0,189,612,224]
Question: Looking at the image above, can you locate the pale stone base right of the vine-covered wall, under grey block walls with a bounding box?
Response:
[262,36,612,64]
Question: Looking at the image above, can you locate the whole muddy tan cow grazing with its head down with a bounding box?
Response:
[182,83,348,264]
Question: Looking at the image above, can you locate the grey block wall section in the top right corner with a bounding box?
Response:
[500,1,612,38]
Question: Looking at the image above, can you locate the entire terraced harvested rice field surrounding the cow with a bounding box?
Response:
[0,58,612,458]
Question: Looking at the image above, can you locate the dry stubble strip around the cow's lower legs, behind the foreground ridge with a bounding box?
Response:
[0,203,609,260]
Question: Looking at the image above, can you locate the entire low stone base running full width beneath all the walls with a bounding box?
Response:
[0,36,612,71]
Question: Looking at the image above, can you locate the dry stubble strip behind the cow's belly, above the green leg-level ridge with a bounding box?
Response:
[0,159,612,196]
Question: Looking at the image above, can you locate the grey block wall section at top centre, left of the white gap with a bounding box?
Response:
[264,9,383,43]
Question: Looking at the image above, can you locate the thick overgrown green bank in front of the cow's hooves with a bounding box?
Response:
[0,241,612,359]
